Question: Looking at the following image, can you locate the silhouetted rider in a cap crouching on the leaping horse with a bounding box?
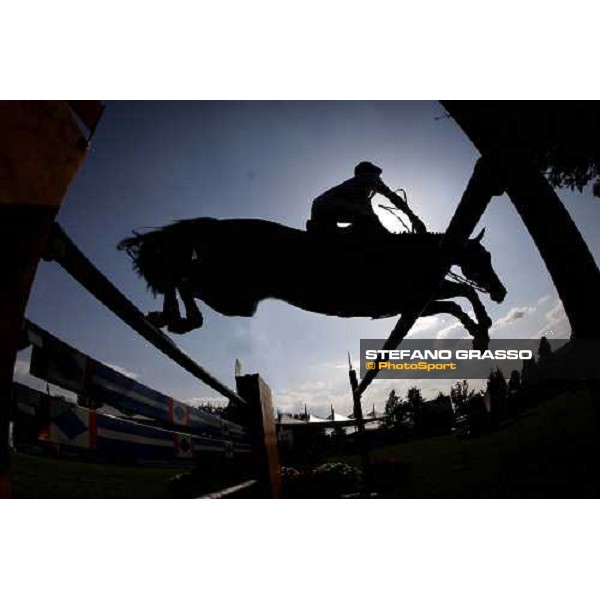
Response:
[309,161,427,233]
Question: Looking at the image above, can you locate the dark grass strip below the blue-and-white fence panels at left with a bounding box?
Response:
[11,453,192,498]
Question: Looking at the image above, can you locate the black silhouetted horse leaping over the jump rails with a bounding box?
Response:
[118,218,506,346]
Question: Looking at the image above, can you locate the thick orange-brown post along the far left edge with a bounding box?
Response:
[0,101,88,496]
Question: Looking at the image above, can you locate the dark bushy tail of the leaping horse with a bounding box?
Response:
[117,229,174,294]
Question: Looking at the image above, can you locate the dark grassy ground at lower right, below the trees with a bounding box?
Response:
[348,391,598,498]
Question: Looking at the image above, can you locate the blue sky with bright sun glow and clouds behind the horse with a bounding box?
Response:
[16,101,600,415]
